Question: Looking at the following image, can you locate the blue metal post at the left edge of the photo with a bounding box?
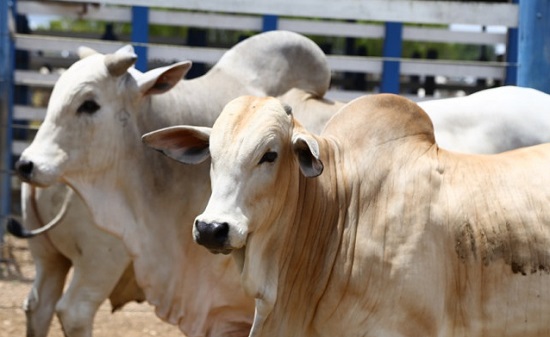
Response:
[0,0,15,236]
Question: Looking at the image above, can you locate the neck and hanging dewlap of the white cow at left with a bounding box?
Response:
[69,77,252,336]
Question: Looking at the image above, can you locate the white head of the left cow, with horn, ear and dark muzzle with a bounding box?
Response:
[16,46,191,186]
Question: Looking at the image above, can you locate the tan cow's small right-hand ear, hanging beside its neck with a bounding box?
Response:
[292,133,324,178]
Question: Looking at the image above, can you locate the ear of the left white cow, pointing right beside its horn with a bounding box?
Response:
[137,61,192,95]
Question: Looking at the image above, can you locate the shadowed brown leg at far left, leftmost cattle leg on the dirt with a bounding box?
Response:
[23,249,71,337]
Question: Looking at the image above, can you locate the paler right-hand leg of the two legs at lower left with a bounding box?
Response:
[56,246,130,337]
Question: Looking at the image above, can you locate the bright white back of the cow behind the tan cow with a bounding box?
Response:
[419,86,550,154]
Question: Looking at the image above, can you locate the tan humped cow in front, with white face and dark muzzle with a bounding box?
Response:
[144,95,550,337]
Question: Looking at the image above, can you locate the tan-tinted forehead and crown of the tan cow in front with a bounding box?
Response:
[210,96,293,159]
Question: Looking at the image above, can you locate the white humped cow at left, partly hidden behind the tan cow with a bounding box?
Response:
[12,31,338,337]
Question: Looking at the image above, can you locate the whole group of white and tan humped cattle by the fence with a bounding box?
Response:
[9,31,550,337]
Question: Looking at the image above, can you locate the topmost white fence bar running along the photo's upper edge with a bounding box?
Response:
[51,0,518,27]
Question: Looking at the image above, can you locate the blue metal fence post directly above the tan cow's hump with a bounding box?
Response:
[380,22,403,94]
